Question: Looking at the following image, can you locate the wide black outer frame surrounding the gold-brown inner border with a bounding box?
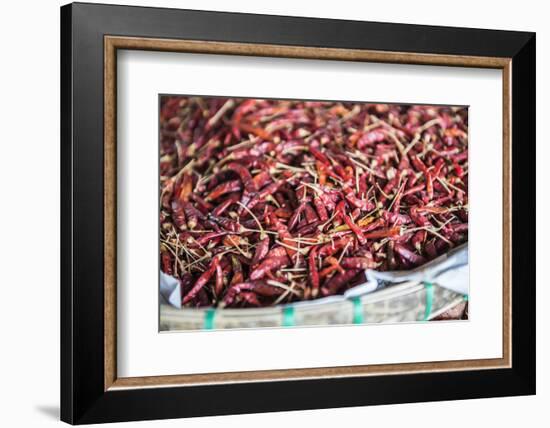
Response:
[61,3,536,424]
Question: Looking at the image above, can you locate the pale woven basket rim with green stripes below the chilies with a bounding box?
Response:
[160,282,465,331]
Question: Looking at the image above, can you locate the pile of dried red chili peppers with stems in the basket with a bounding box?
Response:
[160,96,468,307]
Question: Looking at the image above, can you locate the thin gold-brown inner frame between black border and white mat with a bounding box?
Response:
[104,36,512,391]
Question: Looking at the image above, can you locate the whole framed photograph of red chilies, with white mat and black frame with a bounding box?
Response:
[61,3,535,424]
